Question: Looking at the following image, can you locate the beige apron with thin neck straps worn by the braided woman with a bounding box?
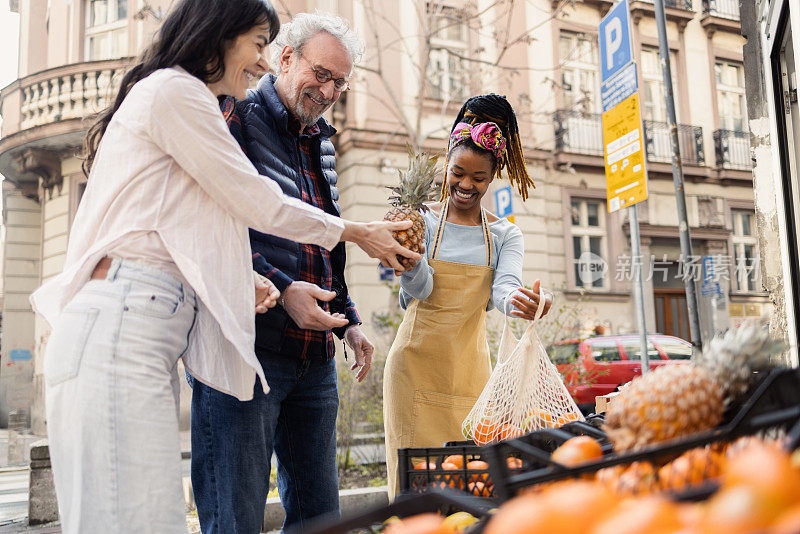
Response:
[383,204,493,500]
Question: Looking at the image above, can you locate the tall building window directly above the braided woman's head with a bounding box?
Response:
[428,4,469,101]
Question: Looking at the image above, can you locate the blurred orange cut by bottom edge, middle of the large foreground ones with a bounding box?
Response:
[588,496,683,534]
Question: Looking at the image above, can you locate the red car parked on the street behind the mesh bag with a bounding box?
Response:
[547,334,692,408]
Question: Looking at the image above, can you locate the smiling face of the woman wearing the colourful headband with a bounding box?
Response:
[447,146,496,216]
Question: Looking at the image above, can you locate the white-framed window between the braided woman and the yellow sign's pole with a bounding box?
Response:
[570,198,607,289]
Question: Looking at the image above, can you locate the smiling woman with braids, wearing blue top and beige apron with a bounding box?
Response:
[383,94,552,496]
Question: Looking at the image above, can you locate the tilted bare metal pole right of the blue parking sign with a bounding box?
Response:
[654,0,703,351]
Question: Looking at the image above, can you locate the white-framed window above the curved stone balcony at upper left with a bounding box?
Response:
[85,0,128,61]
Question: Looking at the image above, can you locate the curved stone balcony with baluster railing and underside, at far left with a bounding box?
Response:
[0,58,131,191]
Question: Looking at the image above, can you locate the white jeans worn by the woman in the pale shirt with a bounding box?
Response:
[44,260,196,534]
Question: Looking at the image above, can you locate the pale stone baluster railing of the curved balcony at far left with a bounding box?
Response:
[0,59,129,136]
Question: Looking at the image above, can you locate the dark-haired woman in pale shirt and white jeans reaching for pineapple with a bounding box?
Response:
[32,0,418,534]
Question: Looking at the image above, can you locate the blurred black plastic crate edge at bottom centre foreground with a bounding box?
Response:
[296,490,494,534]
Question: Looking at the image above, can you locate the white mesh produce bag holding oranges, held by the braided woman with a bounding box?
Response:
[461,291,584,445]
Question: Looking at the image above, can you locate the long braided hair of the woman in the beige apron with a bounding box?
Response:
[440,93,536,201]
